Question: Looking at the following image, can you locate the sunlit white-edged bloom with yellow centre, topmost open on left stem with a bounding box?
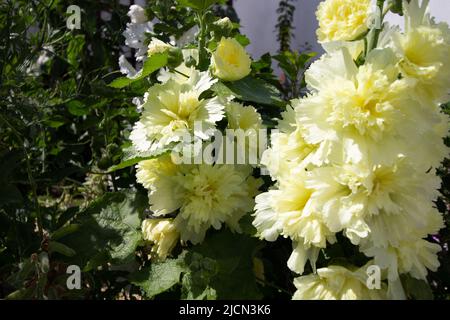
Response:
[130,71,225,151]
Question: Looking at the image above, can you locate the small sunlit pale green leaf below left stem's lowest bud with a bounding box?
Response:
[129,254,186,298]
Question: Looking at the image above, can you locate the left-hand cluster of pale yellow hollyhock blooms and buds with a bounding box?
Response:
[119,7,262,259]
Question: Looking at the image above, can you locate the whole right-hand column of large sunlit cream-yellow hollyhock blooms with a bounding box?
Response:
[254,0,450,299]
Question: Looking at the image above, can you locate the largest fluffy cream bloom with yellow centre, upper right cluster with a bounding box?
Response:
[294,49,445,168]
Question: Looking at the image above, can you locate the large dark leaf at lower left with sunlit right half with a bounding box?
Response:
[58,191,148,271]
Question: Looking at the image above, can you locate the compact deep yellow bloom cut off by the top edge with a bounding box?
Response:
[316,0,371,42]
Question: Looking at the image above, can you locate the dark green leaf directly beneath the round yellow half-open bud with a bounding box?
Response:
[213,76,285,107]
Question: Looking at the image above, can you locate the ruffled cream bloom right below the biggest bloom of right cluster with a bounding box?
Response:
[305,159,440,246]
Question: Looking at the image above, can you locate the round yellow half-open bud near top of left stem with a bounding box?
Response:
[211,38,252,81]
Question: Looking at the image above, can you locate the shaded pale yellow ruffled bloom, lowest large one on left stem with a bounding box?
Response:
[136,156,260,244]
